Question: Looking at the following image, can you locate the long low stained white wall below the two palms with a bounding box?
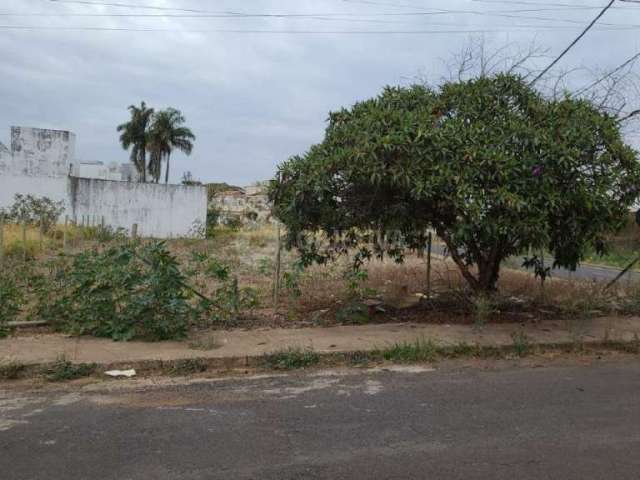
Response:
[69,177,207,238]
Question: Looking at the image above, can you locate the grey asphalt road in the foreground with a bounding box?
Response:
[0,358,640,480]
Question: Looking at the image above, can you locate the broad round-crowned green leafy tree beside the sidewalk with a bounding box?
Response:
[270,74,640,292]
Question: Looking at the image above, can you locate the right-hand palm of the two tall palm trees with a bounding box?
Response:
[149,108,196,183]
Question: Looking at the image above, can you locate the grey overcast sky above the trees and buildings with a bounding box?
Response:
[0,0,640,185]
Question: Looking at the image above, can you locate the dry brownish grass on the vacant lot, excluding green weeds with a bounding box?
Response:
[5,225,640,326]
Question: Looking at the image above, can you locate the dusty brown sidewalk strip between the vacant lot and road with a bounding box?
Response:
[0,317,640,365]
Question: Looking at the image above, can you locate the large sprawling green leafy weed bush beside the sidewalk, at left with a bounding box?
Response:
[37,242,193,340]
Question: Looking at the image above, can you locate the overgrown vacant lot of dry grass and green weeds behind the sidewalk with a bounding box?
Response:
[0,214,640,342]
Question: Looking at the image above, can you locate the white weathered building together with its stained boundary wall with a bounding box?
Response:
[0,127,207,238]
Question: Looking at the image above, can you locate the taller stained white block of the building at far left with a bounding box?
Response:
[9,127,76,177]
